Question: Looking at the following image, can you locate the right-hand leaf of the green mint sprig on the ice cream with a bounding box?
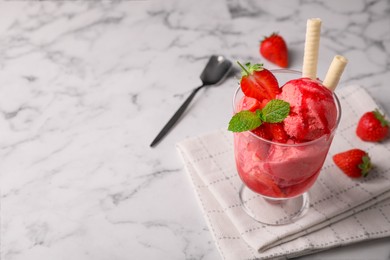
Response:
[260,99,290,123]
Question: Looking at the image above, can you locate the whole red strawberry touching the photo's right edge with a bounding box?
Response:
[356,109,390,142]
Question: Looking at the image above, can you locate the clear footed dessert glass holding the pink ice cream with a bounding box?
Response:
[233,69,341,225]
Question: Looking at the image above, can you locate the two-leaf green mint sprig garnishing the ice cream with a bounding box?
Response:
[228,99,290,132]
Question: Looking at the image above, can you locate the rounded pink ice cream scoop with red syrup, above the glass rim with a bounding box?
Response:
[276,78,337,142]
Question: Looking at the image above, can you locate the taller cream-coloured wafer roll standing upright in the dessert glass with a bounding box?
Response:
[302,18,321,79]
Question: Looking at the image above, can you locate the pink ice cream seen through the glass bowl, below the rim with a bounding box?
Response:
[234,132,331,198]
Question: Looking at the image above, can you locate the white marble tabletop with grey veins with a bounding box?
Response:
[0,0,390,260]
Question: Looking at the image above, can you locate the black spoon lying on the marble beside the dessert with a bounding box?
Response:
[150,55,232,147]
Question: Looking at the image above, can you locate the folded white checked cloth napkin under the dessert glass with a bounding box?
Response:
[177,85,390,259]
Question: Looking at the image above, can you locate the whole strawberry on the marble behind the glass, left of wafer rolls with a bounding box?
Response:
[260,33,288,68]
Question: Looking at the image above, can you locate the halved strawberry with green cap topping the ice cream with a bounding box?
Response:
[238,62,280,102]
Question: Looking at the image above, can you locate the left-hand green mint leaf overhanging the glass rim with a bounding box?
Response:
[228,110,262,132]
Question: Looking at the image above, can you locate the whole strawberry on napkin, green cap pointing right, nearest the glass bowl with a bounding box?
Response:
[333,148,372,178]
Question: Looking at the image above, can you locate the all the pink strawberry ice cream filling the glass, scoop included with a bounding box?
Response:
[234,78,338,198]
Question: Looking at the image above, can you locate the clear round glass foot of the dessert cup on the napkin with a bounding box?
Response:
[239,184,310,226]
